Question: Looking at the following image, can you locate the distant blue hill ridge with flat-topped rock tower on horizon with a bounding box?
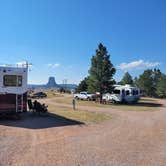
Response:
[28,77,77,89]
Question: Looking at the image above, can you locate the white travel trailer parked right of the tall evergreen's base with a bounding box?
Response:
[103,84,141,103]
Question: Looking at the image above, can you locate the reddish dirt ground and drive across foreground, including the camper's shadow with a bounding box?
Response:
[0,99,166,166]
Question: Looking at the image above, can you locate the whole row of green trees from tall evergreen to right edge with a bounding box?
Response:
[77,43,166,98]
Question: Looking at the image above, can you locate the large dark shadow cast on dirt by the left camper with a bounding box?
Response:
[0,112,84,129]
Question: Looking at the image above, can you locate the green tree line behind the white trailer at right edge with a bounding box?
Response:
[118,69,166,98]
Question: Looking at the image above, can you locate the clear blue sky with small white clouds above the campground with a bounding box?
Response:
[0,0,166,84]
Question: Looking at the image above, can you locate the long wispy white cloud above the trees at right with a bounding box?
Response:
[118,60,160,70]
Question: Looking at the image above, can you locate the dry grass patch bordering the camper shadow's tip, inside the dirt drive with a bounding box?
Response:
[48,105,111,123]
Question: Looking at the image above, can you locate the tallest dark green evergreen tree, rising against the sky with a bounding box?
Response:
[89,43,116,95]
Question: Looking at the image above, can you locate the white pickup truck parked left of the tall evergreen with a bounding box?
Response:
[74,92,95,100]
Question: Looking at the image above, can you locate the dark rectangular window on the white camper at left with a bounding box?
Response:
[3,75,22,86]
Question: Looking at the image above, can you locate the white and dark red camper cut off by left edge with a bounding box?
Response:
[0,66,28,114]
